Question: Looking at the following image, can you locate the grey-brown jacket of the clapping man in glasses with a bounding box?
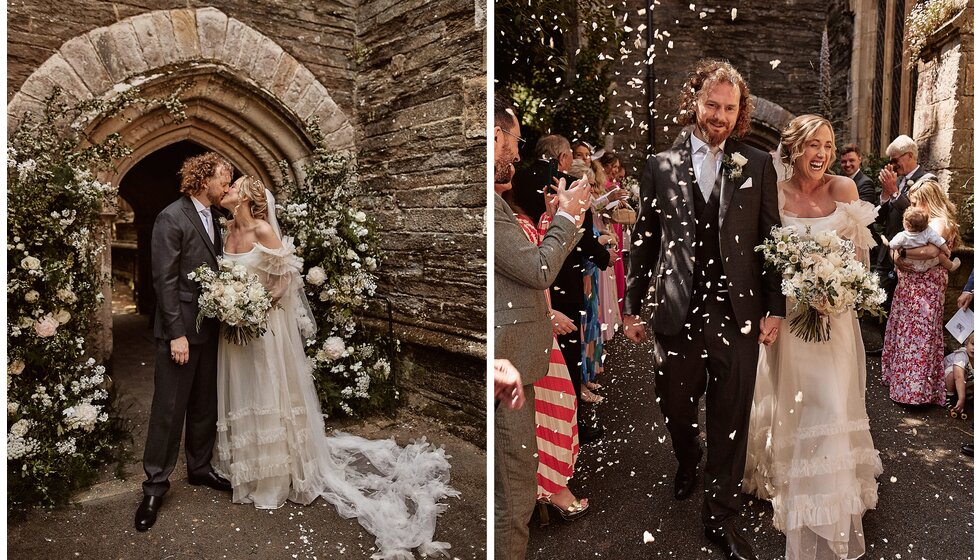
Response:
[493,194,582,385]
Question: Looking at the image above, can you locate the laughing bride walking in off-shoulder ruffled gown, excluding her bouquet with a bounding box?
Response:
[742,115,882,560]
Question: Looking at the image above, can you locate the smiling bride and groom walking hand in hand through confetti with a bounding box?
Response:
[624,60,882,559]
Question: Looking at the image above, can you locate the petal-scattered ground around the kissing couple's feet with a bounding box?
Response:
[6,315,487,560]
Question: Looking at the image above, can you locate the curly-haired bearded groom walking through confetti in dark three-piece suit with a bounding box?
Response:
[624,60,786,559]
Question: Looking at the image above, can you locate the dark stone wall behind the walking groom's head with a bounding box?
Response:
[607,0,828,176]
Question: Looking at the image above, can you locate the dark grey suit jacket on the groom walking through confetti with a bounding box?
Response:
[623,131,786,336]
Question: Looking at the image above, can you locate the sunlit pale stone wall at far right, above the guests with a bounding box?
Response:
[913,2,975,234]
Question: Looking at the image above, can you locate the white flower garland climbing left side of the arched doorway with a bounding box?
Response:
[7,87,182,514]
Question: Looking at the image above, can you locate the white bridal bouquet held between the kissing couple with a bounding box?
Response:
[187,259,272,346]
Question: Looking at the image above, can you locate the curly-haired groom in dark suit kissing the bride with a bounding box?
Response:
[136,152,233,531]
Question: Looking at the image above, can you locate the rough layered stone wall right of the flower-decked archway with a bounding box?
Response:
[355,0,487,439]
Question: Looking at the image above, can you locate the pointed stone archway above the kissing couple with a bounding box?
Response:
[7,8,354,357]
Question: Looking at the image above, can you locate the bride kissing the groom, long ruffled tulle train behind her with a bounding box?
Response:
[212,177,459,560]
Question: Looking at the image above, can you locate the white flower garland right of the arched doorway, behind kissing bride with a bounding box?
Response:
[276,122,397,416]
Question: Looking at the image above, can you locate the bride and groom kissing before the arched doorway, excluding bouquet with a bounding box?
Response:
[135,152,458,558]
